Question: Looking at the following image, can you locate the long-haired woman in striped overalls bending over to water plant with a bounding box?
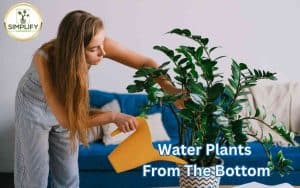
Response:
[14,11,178,188]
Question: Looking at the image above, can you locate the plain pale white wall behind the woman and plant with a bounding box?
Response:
[0,0,300,172]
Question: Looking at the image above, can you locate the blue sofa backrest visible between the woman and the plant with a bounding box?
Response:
[89,90,178,139]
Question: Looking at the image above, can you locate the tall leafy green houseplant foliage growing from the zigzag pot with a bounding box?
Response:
[127,28,297,187]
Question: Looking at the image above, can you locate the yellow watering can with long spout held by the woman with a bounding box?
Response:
[108,117,187,173]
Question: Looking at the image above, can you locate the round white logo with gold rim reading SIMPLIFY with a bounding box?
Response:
[4,3,43,40]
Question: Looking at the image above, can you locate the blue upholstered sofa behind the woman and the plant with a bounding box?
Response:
[78,90,300,188]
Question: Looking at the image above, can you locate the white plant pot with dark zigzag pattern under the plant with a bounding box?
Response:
[179,159,224,188]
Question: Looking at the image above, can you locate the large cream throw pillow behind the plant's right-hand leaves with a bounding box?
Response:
[244,82,300,146]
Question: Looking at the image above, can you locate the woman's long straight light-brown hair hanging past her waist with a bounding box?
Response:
[41,10,103,151]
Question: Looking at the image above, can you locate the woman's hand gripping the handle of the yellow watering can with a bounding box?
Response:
[113,112,138,133]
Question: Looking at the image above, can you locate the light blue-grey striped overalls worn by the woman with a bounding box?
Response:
[14,58,79,188]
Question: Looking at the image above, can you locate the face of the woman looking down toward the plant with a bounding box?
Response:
[85,29,105,65]
